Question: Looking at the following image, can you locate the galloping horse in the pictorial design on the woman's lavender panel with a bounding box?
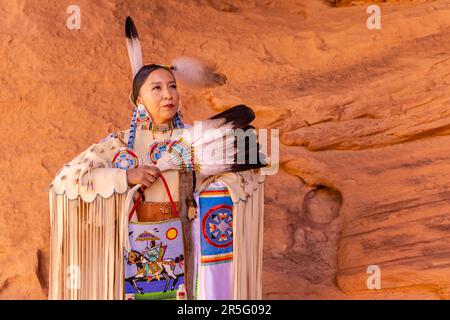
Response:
[125,250,184,294]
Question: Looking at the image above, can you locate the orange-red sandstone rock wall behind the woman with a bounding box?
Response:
[0,0,450,299]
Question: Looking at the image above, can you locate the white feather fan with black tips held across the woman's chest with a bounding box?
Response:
[156,105,267,176]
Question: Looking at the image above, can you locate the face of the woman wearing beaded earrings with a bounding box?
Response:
[136,68,179,124]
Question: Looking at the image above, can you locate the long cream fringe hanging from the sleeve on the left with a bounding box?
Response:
[49,189,129,300]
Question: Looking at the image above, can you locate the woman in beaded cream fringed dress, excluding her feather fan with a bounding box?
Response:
[49,19,264,299]
